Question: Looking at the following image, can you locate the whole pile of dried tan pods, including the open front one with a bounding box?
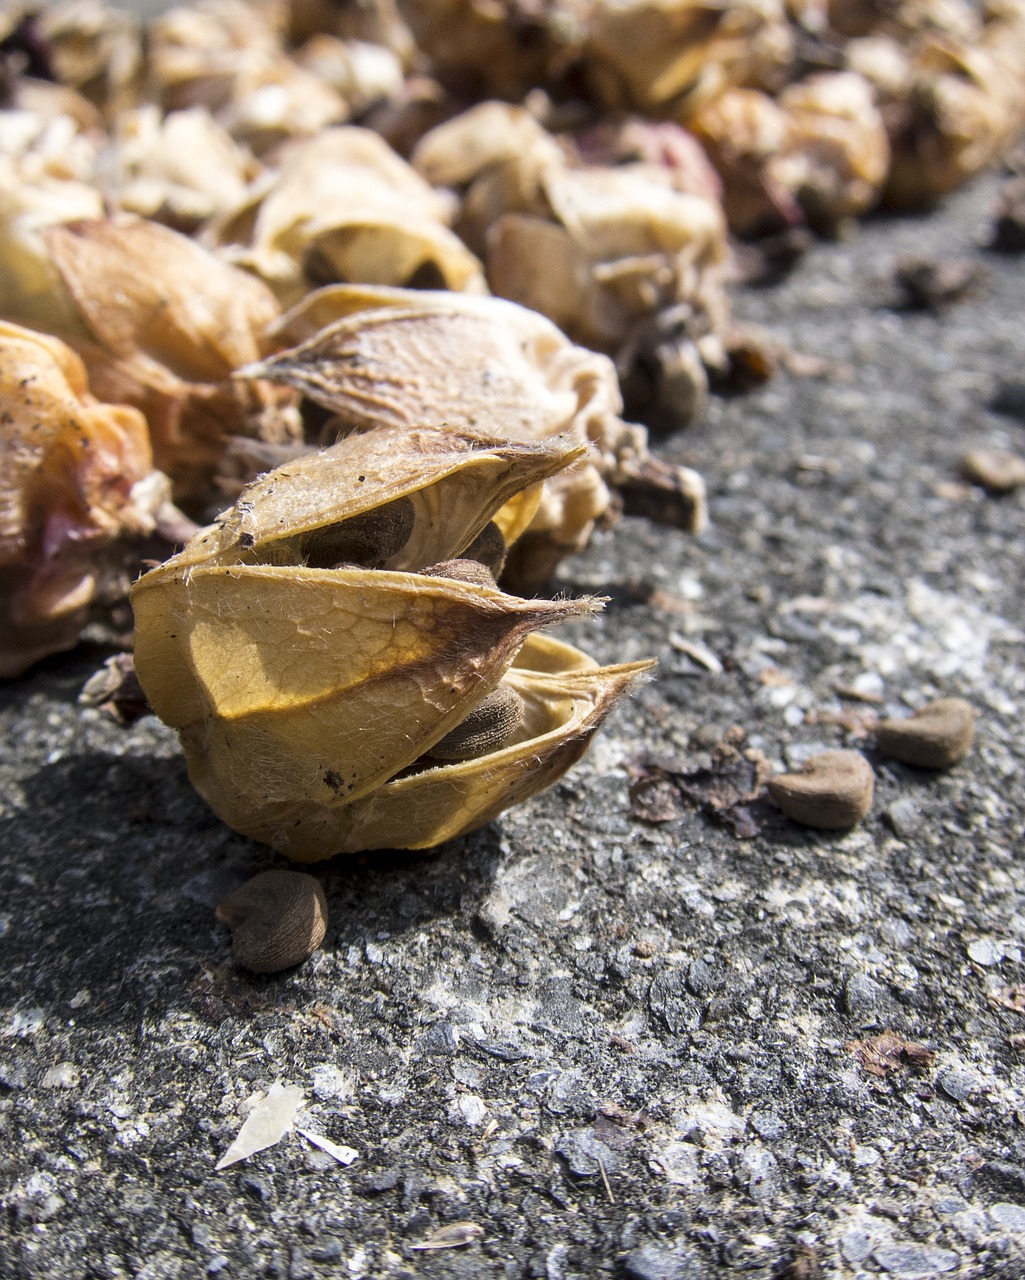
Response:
[0,0,1025,858]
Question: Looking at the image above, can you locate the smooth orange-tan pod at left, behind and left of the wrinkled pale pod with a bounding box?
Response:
[0,218,301,504]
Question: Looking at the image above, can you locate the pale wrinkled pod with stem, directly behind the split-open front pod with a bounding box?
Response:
[242,285,704,589]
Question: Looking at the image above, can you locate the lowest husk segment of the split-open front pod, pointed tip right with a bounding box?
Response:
[269,635,653,861]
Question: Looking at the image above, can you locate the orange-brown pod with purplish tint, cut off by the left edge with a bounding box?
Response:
[0,323,170,676]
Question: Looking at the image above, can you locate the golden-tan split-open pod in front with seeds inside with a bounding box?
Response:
[132,428,649,860]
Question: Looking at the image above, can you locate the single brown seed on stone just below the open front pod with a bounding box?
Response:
[216,870,328,973]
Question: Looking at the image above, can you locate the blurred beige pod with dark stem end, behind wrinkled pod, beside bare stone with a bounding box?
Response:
[413,102,728,426]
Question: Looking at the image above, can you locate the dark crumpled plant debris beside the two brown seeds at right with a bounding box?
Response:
[630,727,772,840]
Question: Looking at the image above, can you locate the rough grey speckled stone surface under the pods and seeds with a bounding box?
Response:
[0,172,1025,1280]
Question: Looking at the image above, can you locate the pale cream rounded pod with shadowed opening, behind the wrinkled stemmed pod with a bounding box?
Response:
[210,127,485,305]
